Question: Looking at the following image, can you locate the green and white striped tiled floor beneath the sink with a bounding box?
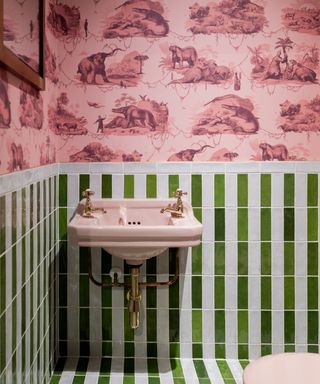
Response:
[50,358,248,384]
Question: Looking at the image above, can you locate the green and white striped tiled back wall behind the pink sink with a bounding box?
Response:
[58,163,320,359]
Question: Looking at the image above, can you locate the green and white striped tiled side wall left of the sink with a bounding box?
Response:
[0,165,58,384]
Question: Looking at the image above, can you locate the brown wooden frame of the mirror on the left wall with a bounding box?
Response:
[0,0,45,91]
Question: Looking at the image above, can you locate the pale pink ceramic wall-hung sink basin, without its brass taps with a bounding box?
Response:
[68,199,202,265]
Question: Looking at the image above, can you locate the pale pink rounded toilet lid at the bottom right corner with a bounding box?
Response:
[243,352,320,384]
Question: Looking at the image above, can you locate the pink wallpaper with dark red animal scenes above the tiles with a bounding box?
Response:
[0,0,320,173]
